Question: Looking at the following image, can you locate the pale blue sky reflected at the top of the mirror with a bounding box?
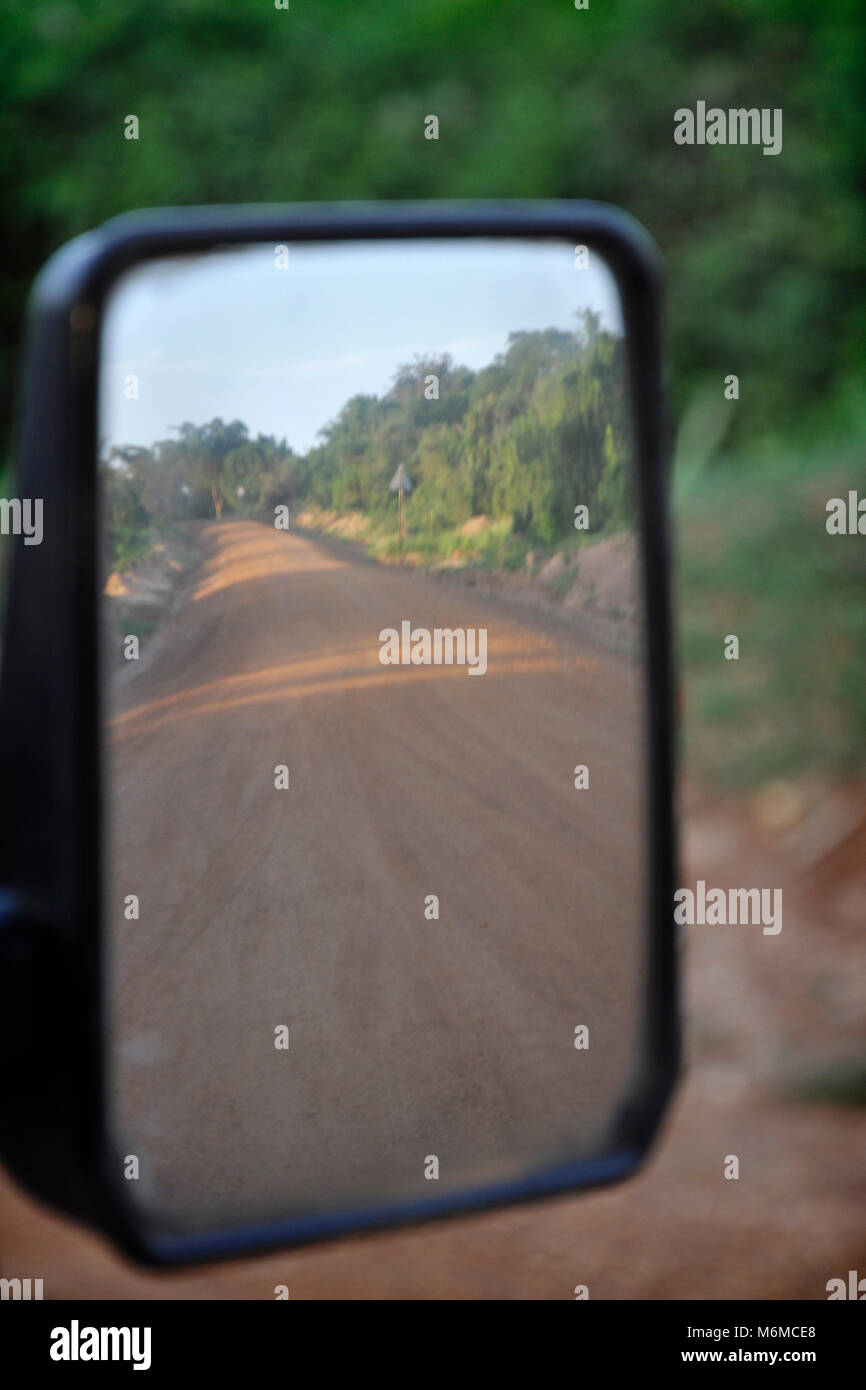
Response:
[100,239,623,453]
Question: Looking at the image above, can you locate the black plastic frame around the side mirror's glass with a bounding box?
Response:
[0,202,680,1265]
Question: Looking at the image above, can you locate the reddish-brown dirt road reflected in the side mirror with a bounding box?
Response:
[108,521,644,1227]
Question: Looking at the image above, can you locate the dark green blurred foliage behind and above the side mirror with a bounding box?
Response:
[0,0,866,453]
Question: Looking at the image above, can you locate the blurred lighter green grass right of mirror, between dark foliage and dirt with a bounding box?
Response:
[676,405,866,788]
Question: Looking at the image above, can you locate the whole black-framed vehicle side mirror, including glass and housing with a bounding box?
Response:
[0,203,678,1264]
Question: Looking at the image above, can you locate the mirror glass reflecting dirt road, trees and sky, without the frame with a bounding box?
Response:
[100,239,646,1234]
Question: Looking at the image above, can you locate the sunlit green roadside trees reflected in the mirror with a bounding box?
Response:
[103,313,632,564]
